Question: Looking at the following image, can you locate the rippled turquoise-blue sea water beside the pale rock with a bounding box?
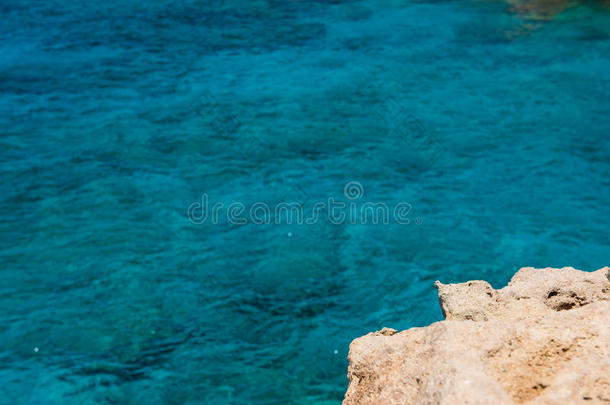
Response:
[0,1,610,404]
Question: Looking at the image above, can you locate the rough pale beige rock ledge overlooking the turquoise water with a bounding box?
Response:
[343,267,610,405]
